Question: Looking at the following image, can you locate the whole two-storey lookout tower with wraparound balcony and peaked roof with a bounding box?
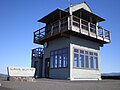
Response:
[31,2,110,80]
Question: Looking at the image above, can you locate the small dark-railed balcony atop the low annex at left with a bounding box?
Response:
[32,48,44,59]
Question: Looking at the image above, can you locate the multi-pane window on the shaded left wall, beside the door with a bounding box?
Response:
[50,48,68,68]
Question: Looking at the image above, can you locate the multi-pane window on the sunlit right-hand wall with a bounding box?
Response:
[73,49,98,69]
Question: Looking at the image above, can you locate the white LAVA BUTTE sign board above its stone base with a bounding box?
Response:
[8,66,35,77]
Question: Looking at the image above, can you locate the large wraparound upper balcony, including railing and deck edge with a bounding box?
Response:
[34,15,110,44]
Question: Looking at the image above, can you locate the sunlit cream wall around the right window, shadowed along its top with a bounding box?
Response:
[70,36,101,80]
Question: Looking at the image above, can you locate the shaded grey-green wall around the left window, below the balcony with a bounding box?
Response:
[43,37,70,79]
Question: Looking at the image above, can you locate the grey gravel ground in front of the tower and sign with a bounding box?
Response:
[0,79,120,90]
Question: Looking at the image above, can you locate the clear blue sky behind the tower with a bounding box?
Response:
[0,0,120,74]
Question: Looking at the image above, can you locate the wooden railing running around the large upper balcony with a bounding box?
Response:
[34,15,110,42]
